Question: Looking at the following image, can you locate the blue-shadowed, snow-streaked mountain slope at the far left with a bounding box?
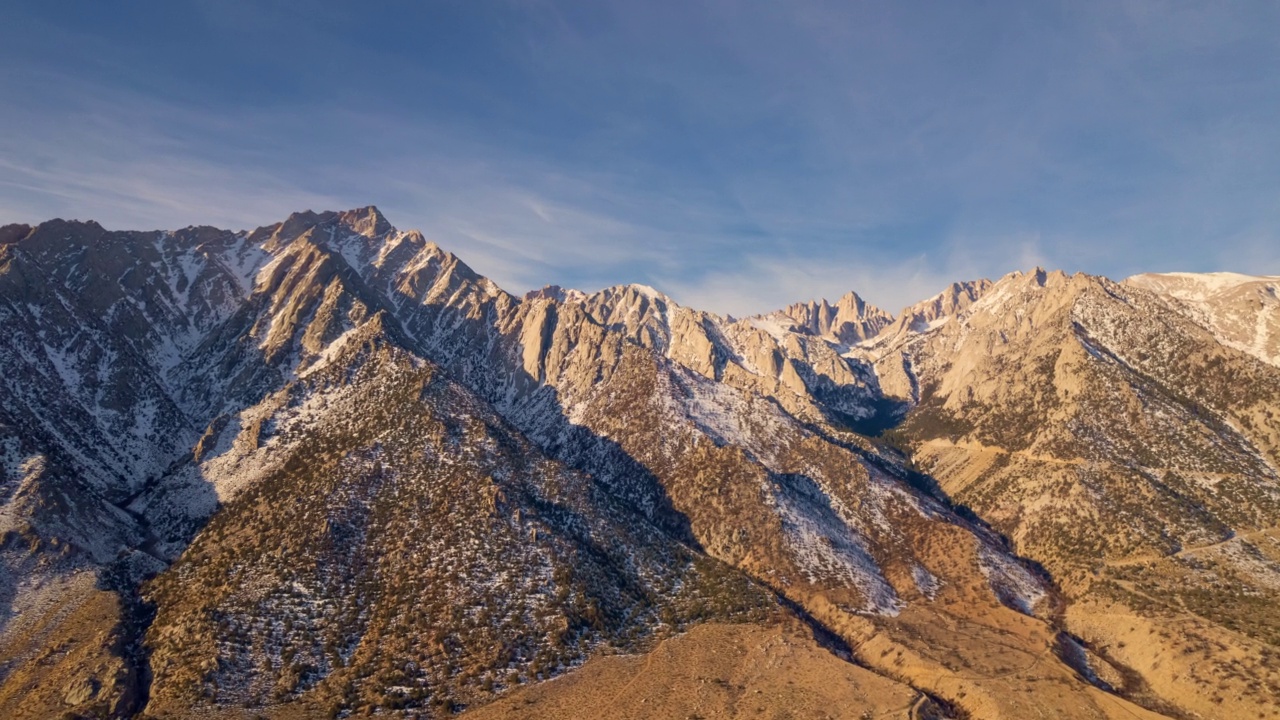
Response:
[0,220,260,562]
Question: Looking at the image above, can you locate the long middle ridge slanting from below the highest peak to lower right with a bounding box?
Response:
[282,219,1172,717]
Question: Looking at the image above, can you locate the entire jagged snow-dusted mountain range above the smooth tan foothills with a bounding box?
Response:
[0,208,1276,717]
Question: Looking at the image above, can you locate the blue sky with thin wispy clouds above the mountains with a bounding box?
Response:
[0,0,1280,314]
